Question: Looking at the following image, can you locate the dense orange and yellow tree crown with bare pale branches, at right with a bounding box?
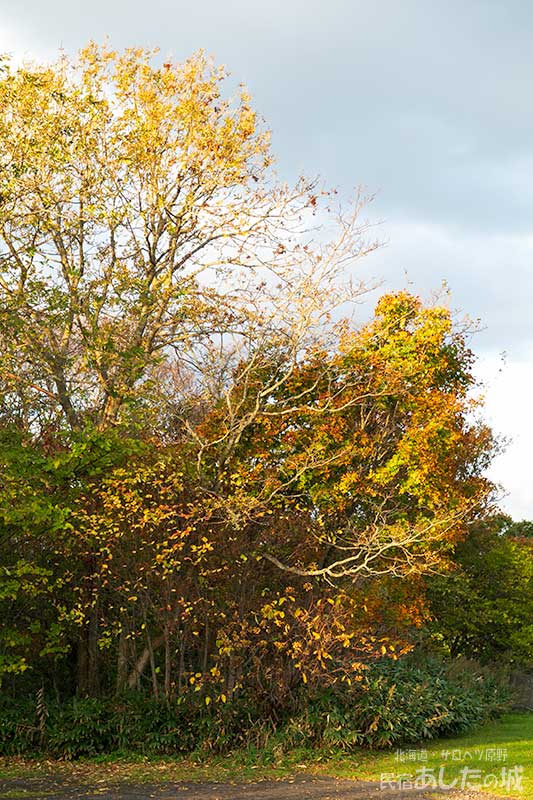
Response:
[182,292,493,579]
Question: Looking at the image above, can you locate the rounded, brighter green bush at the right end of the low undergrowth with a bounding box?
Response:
[287,659,510,750]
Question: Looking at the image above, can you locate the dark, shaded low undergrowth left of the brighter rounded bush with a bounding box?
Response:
[0,695,273,759]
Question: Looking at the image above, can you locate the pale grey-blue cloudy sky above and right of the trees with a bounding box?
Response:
[0,0,533,519]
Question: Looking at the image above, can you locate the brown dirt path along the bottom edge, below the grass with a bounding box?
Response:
[0,776,502,800]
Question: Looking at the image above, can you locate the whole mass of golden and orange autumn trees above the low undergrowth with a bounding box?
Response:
[0,45,493,714]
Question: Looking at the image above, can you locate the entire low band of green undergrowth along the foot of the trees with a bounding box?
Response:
[0,659,508,759]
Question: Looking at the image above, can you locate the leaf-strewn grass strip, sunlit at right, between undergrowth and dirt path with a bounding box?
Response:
[0,713,533,800]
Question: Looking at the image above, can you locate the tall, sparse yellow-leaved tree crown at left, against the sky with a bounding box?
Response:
[0,44,373,432]
